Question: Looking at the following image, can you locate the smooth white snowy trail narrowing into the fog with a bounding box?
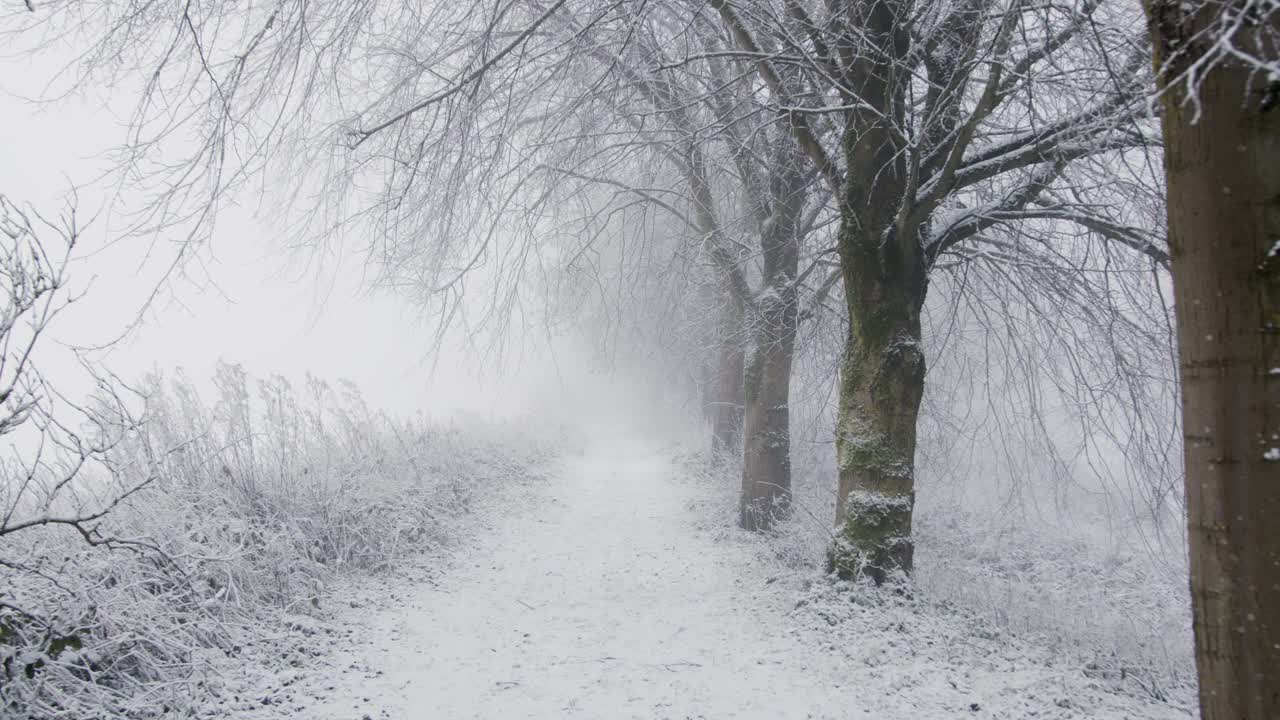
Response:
[308,427,855,719]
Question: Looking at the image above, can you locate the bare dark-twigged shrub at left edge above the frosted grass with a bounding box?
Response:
[0,195,152,543]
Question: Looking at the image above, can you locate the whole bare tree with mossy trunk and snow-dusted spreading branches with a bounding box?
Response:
[713,0,1161,582]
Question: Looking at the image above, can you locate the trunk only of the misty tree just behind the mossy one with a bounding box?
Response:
[739,284,799,530]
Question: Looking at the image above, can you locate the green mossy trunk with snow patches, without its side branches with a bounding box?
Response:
[831,0,928,583]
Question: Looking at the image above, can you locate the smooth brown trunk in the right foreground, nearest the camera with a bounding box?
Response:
[1148,3,1280,720]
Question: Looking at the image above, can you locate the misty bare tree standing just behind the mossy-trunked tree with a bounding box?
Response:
[519,6,833,529]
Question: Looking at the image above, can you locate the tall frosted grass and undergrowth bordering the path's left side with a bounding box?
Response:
[0,365,564,720]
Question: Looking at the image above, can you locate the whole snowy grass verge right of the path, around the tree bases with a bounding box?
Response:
[682,448,1196,708]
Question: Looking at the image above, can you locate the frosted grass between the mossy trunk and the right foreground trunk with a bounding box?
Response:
[916,514,1196,700]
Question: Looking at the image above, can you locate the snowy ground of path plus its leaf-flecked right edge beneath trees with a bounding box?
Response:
[217,422,1192,720]
